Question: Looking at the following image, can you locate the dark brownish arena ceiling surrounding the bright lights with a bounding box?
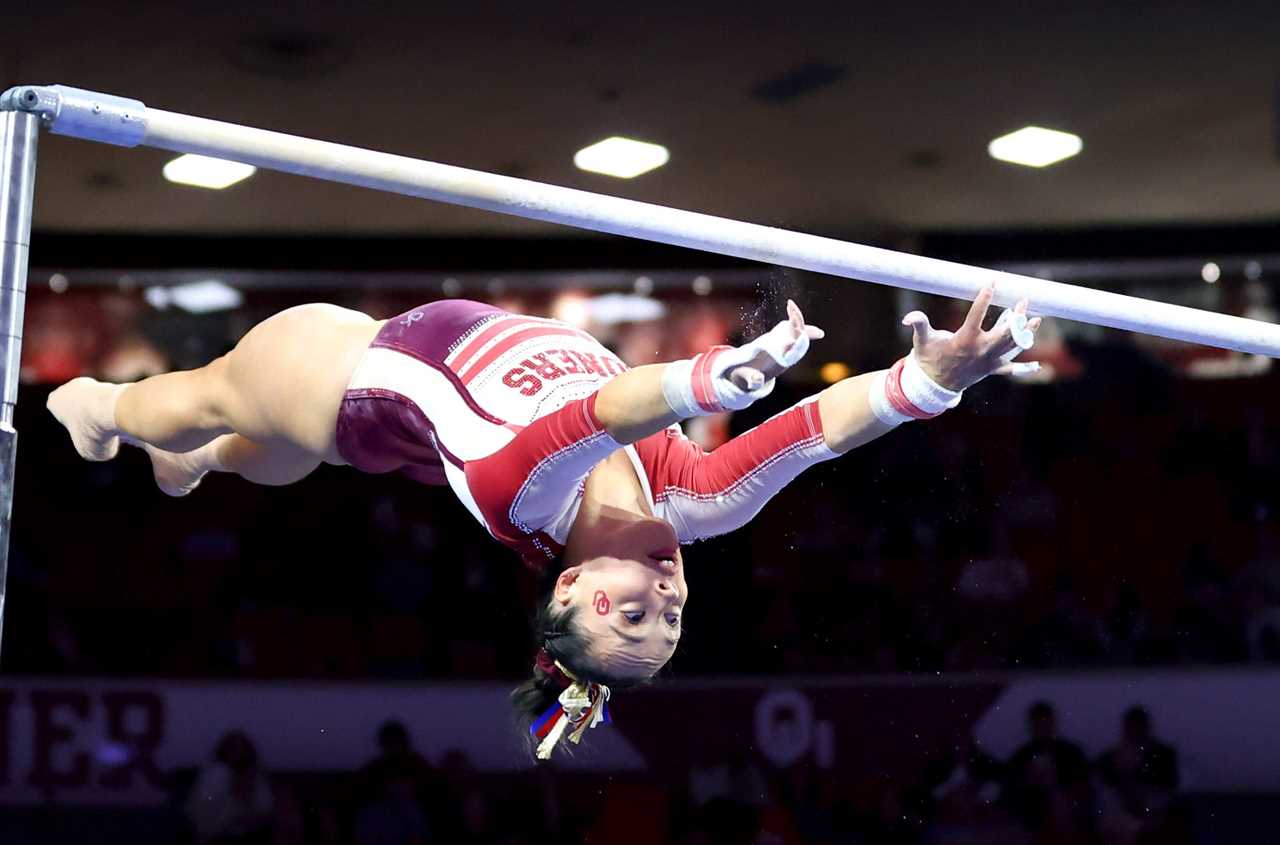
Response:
[10,0,1280,236]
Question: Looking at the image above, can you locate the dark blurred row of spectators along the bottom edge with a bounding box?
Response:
[147,702,1177,845]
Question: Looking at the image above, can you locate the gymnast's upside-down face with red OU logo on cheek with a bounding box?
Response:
[556,517,689,679]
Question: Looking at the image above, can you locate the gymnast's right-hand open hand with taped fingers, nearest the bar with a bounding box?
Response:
[902,283,1041,390]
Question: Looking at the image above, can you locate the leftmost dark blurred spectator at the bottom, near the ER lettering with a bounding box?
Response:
[186,731,275,845]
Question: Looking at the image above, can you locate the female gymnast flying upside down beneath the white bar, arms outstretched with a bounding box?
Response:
[49,286,1039,759]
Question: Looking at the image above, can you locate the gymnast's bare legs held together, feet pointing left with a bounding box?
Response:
[49,305,381,494]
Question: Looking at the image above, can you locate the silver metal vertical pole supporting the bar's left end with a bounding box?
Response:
[0,111,40,652]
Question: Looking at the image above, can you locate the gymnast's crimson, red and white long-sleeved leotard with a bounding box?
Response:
[337,300,836,568]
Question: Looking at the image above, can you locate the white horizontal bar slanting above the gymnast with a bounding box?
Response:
[17,92,1280,357]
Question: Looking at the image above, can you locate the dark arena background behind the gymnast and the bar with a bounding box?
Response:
[0,0,1280,845]
